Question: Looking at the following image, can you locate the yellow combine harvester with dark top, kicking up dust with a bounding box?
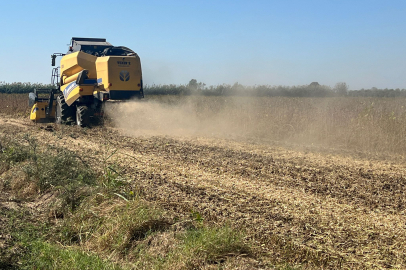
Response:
[29,37,144,127]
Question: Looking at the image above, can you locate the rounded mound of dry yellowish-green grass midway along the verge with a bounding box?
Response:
[58,196,170,247]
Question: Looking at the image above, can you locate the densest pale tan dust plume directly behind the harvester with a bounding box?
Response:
[106,96,254,137]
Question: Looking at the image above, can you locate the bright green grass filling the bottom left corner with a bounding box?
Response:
[0,211,122,269]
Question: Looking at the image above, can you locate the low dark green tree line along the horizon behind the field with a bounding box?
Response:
[0,79,406,97]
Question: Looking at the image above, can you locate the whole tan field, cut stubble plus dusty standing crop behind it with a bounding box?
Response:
[0,97,406,269]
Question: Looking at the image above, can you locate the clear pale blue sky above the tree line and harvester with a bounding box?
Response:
[0,0,406,89]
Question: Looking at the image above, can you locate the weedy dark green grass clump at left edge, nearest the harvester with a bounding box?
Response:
[0,135,99,211]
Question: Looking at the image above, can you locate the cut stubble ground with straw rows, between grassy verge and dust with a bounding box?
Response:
[0,116,406,269]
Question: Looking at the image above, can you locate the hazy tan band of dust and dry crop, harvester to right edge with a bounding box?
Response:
[106,96,406,155]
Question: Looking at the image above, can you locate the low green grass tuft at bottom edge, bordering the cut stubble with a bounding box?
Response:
[123,226,250,269]
